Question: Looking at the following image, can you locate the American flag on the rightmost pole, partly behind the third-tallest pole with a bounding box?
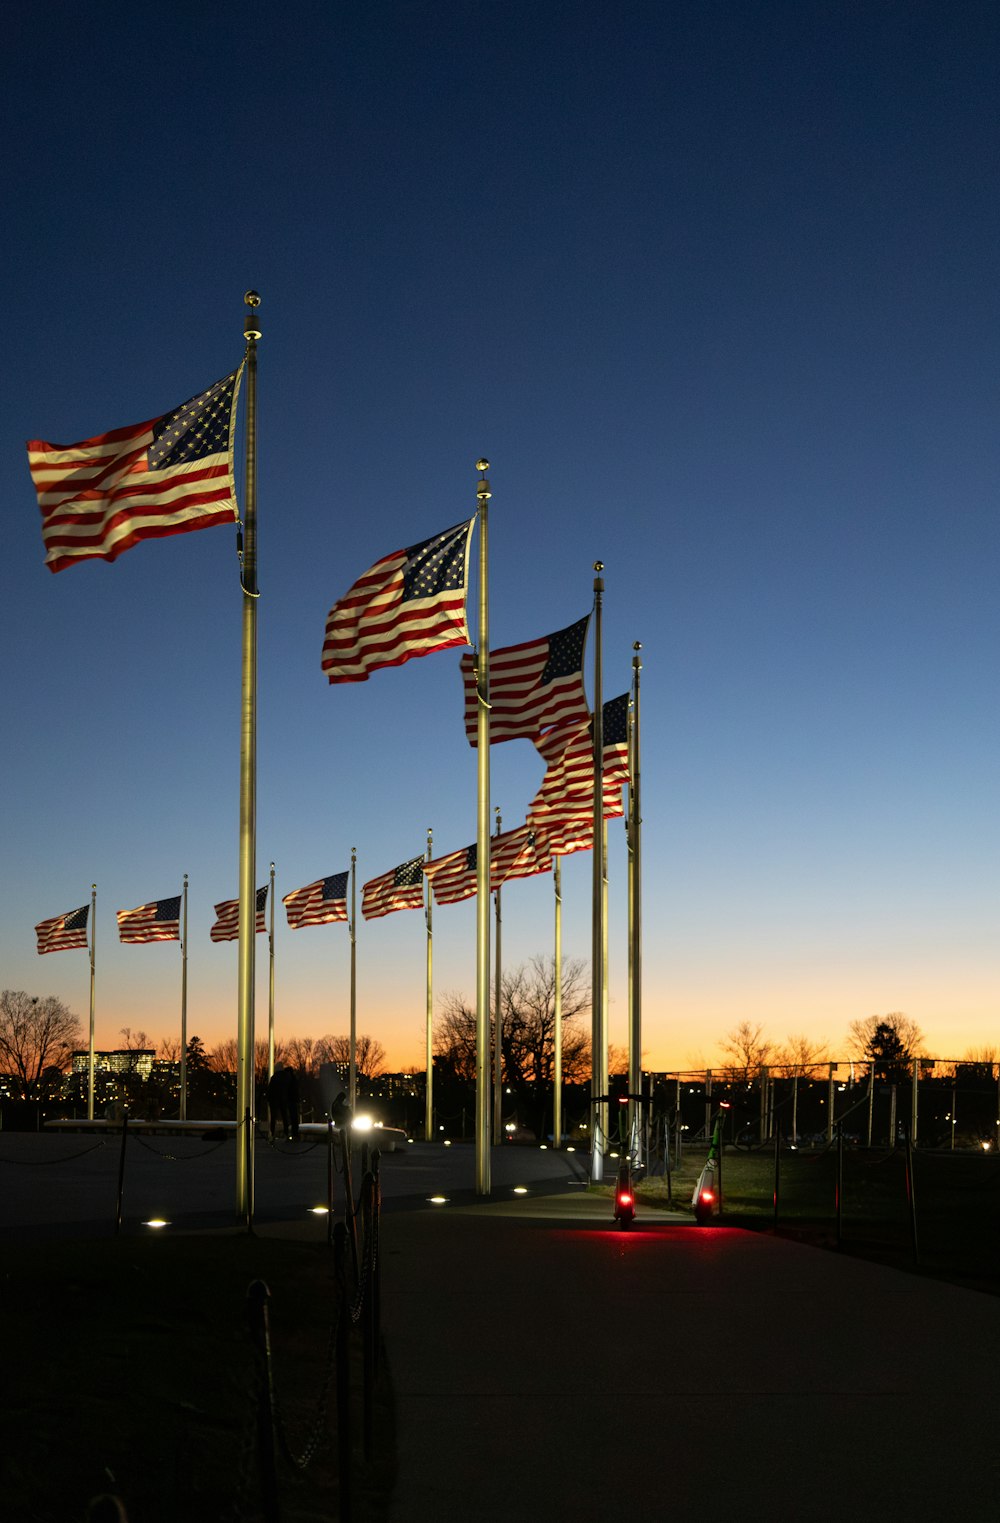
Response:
[528,693,629,856]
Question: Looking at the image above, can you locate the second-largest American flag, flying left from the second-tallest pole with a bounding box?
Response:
[323,518,475,682]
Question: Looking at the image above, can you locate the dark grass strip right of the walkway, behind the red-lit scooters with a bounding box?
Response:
[638,1145,1000,1295]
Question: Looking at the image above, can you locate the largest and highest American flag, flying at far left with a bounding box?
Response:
[27,366,244,571]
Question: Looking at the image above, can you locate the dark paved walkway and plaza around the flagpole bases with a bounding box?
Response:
[0,1133,1000,1523]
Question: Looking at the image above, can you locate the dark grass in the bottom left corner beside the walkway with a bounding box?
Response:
[0,1232,393,1523]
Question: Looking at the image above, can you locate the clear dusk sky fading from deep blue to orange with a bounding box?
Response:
[0,0,1000,1068]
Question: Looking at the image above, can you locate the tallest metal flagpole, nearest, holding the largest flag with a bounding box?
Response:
[236,291,260,1223]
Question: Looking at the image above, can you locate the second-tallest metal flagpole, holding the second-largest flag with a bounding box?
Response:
[476,460,492,1196]
